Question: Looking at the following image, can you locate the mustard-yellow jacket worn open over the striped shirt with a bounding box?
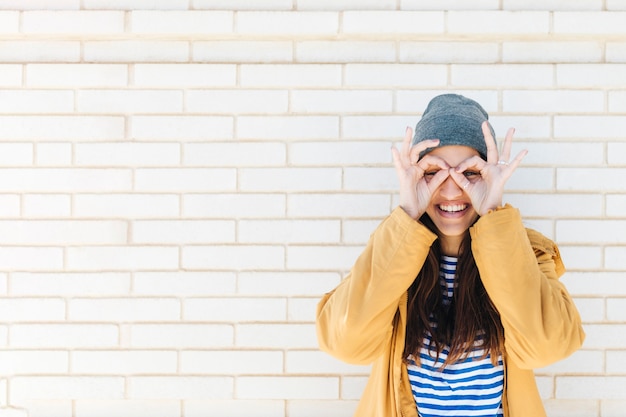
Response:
[317,205,585,417]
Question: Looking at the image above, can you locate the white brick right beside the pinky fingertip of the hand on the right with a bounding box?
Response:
[510,141,604,167]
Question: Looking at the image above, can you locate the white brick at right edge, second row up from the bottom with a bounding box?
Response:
[556,376,626,400]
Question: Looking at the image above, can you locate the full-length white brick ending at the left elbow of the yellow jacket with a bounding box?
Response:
[235,324,318,348]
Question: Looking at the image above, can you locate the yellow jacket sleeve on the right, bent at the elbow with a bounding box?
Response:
[470,205,585,369]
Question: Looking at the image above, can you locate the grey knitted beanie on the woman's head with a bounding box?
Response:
[412,94,496,160]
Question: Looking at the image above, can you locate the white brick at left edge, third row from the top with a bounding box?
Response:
[0,40,80,62]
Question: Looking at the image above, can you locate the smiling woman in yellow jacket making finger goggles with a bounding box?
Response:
[317,94,584,417]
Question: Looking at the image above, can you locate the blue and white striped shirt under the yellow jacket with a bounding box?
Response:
[407,256,504,417]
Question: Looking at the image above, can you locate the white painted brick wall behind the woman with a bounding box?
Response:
[0,0,626,417]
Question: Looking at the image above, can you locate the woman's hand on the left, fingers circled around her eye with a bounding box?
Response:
[391,127,450,220]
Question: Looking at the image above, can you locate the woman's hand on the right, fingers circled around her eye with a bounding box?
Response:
[450,122,528,216]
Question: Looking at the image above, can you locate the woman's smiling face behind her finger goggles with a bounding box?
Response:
[425,145,480,245]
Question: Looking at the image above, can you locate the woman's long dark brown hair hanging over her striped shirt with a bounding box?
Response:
[404,214,504,368]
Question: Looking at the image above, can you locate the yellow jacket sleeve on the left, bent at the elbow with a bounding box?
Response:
[316,207,436,364]
